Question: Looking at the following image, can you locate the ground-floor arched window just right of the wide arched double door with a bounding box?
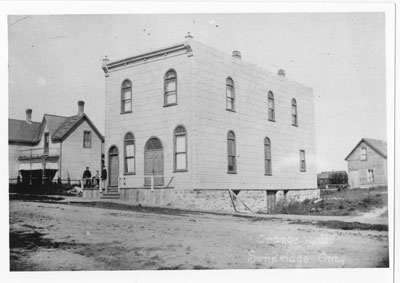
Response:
[174,126,187,172]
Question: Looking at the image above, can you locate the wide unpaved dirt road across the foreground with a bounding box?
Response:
[10,201,388,270]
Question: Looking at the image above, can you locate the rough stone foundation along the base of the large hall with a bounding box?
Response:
[120,188,320,213]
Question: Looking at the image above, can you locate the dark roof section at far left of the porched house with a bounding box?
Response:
[8,119,41,143]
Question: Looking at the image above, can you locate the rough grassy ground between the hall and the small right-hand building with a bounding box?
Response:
[277,187,388,216]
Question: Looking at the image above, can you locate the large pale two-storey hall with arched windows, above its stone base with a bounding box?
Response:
[103,36,319,211]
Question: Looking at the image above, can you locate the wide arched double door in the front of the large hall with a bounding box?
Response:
[144,138,164,186]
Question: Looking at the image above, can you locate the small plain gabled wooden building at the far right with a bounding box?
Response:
[345,138,387,188]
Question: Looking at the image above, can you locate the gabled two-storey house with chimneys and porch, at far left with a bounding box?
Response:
[8,101,104,184]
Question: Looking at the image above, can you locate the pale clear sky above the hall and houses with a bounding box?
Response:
[8,13,387,172]
